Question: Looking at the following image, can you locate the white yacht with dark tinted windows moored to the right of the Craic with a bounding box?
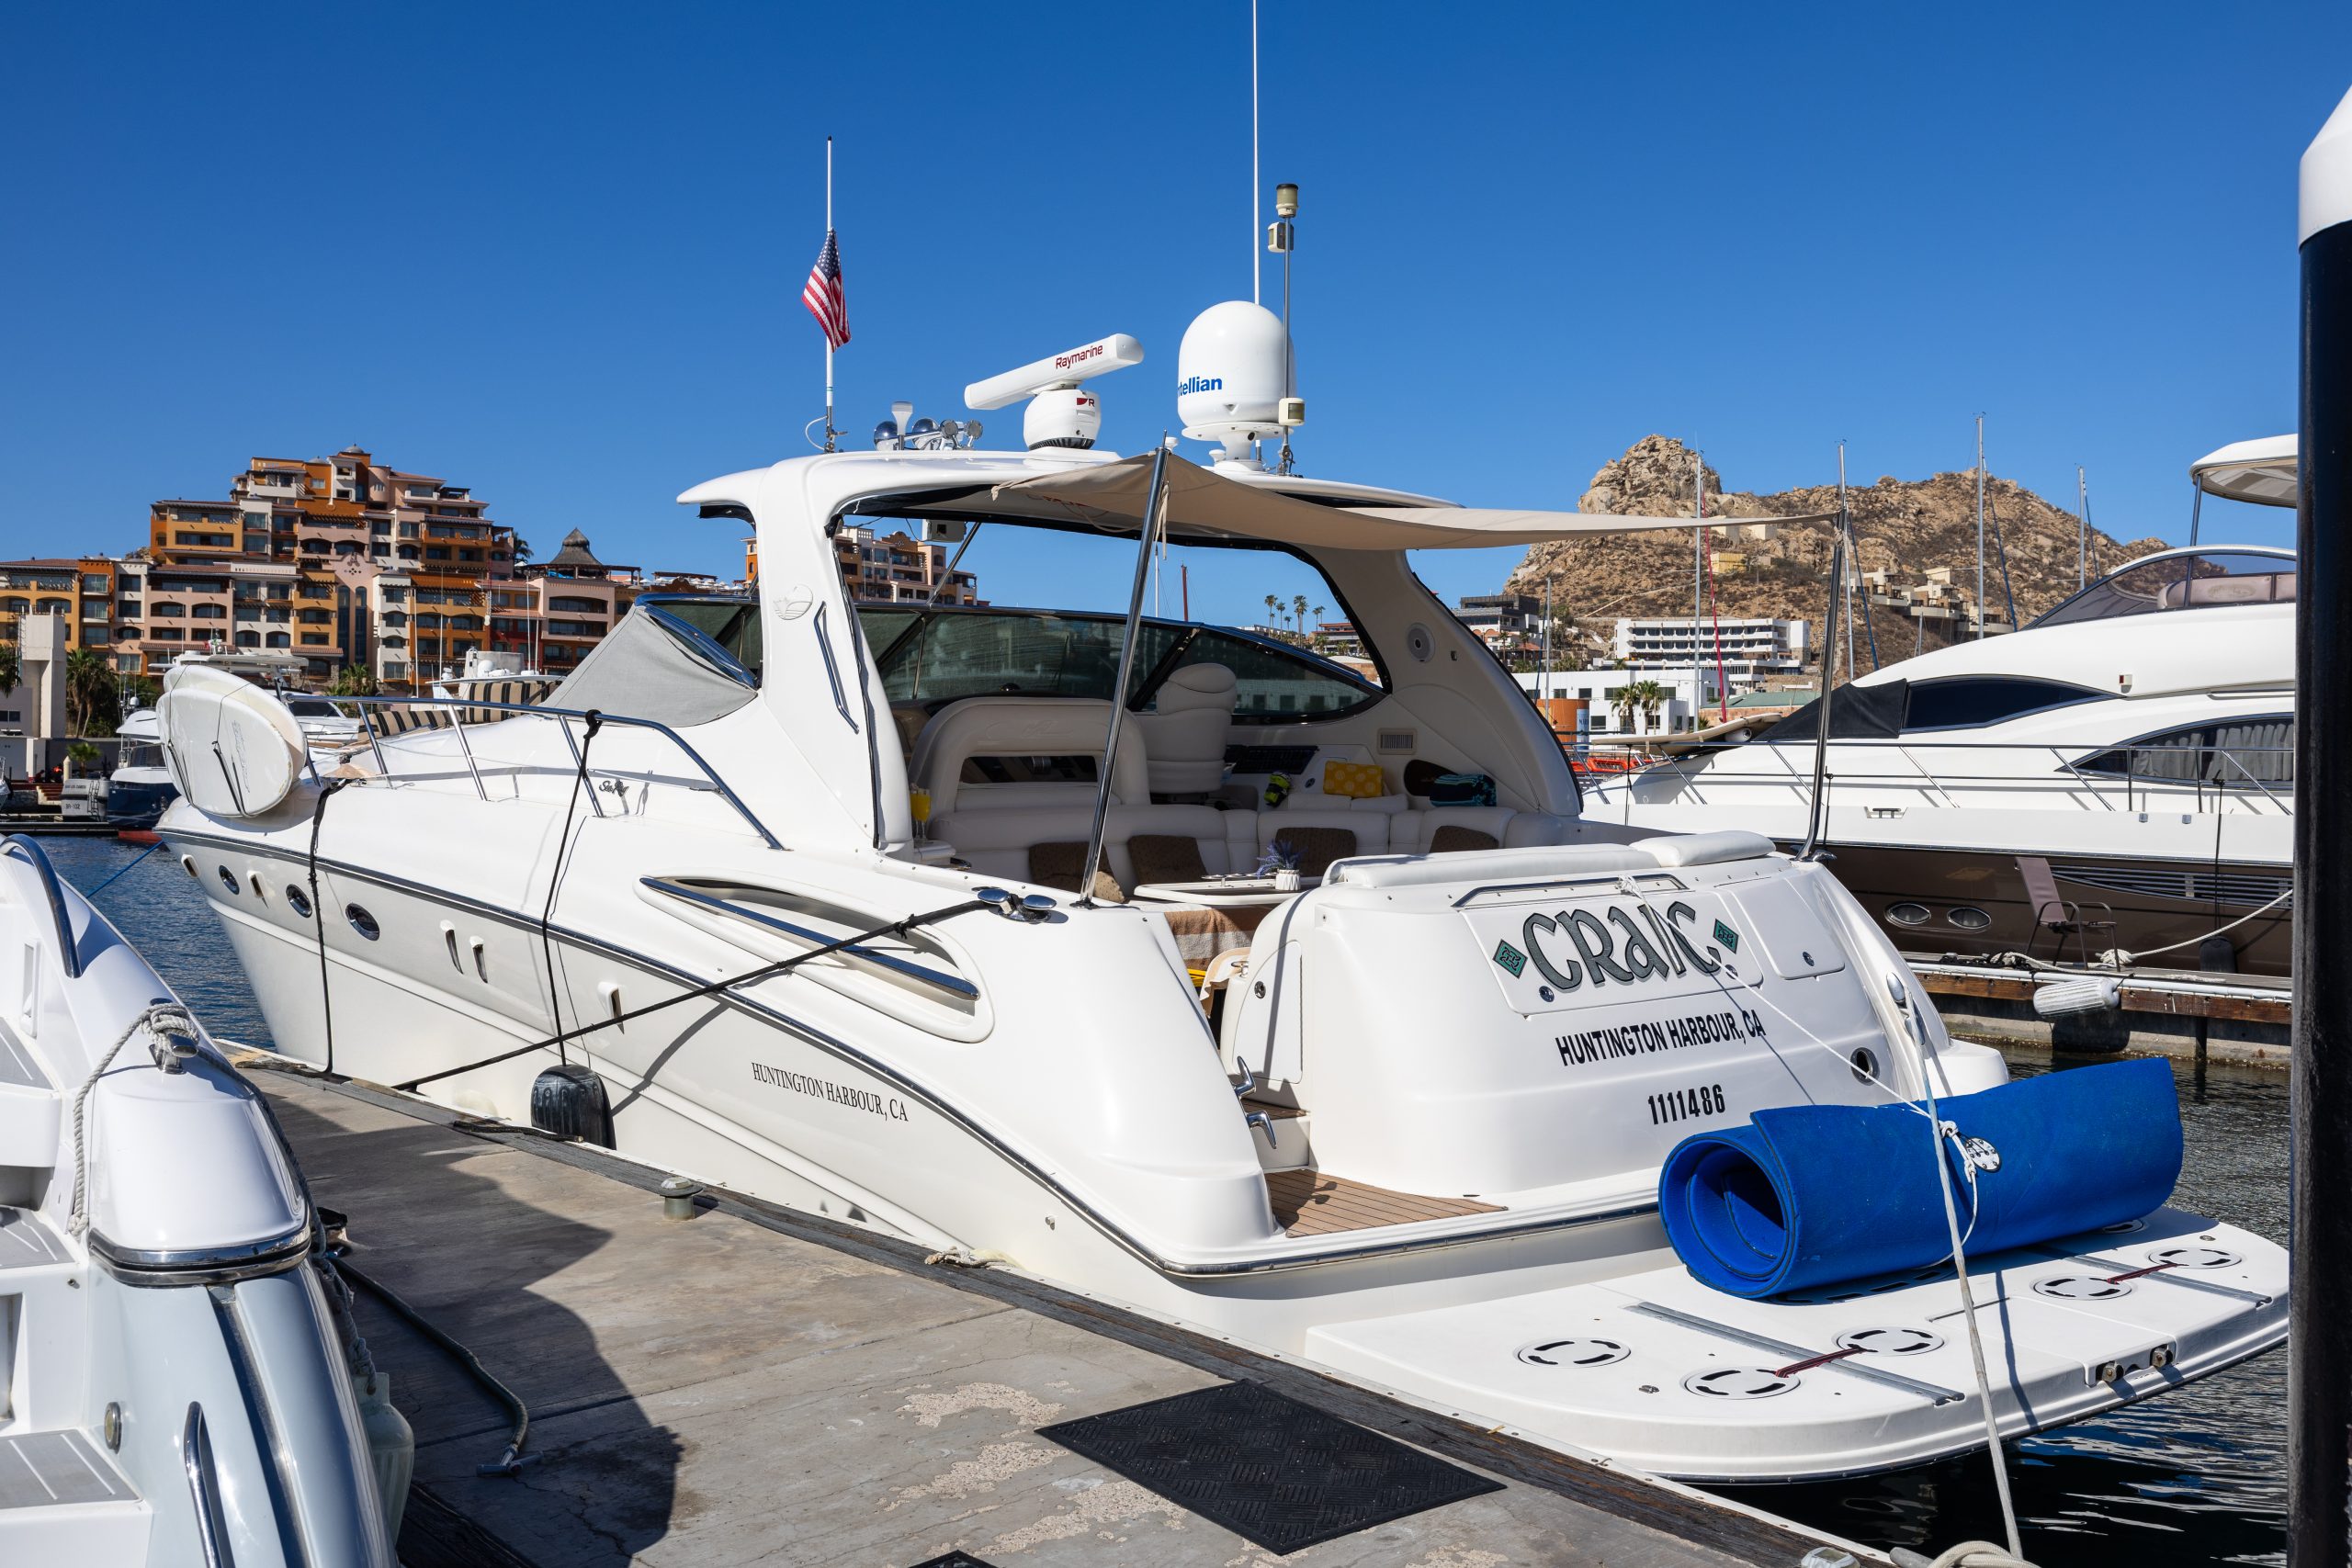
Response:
[1585,434,2296,976]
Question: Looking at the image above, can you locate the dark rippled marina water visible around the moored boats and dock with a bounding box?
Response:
[45,840,2289,1568]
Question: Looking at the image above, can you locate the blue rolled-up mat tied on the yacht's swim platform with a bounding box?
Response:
[1658,1060,2180,1298]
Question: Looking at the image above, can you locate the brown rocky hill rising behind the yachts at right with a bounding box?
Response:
[1505,434,2162,670]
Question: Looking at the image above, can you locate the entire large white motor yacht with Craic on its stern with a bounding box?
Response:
[163,324,2286,1479]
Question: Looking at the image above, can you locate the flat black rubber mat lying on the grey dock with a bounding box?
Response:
[1037,1382,1503,1554]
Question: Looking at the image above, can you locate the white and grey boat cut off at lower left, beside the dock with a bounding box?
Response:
[0,837,404,1568]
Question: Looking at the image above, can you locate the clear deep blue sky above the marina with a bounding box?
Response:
[0,0,2352,621]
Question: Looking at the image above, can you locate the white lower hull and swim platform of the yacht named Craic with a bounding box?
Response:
[169,818,2284,1481]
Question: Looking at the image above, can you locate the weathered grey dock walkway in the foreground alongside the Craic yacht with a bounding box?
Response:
[240,1051,1886,1568]
